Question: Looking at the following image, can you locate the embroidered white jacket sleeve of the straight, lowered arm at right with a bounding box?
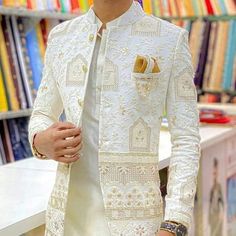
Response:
[164,29,200,228]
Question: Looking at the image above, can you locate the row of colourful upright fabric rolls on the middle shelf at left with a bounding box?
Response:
[0,16,60,112]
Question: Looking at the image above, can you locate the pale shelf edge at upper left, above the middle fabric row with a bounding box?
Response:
[0,6,83,20]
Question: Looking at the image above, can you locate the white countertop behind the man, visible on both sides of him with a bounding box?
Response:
[0,126,236,236]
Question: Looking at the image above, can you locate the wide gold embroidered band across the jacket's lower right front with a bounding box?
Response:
[99,162,163,220]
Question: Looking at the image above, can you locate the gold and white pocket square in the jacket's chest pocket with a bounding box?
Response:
[133,55,160,73]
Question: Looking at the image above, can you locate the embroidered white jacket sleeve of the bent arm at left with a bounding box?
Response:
[28,29,63,157]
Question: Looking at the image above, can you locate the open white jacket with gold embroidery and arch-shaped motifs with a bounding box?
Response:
[29,2,200,236]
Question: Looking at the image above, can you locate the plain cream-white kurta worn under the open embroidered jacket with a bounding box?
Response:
[65,10,123,236]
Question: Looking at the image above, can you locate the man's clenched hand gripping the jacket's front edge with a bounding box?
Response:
[34,122,82,163]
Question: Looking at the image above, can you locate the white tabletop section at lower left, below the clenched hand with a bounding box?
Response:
[0,158,56,236]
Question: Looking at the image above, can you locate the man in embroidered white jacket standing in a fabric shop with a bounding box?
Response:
[29,0,200,236]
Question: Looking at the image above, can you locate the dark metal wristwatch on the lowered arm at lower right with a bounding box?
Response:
[160,220,188,236]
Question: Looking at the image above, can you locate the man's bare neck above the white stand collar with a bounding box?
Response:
[93,0,133,24]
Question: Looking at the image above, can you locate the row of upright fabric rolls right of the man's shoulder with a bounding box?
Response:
[190,20,236,94]
